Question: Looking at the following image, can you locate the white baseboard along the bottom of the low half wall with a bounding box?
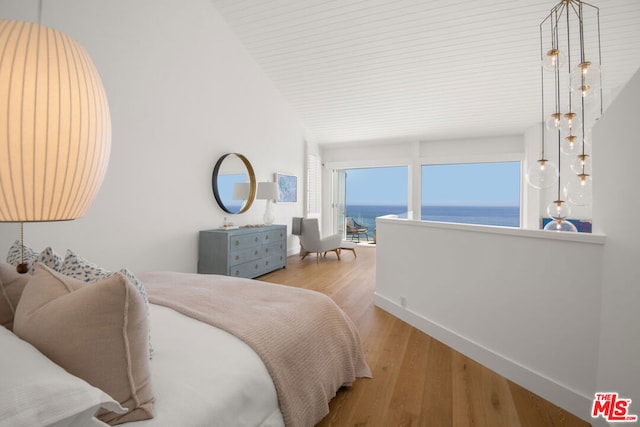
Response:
[374,293,596,426]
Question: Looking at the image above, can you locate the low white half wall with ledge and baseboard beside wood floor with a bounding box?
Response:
[376,219,604,418]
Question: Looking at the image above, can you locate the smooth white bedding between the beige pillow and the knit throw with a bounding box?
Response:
[136,304,284,427]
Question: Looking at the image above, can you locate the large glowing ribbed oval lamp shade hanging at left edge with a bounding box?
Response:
[0,20,111,222]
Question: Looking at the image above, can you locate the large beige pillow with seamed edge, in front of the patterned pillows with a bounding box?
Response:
[14,263,153,425]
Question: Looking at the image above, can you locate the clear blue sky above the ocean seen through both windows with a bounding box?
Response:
[347,162,520,206]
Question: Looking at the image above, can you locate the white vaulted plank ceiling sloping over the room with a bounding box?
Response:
[212,0,640,143]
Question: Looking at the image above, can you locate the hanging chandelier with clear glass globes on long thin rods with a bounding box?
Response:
[527,0,602,231]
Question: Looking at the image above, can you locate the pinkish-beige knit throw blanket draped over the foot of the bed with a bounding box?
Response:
[138,272,371,427]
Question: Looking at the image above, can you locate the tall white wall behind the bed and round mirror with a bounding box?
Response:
[0,0,308,272]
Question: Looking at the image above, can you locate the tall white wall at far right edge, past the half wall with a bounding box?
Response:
[593,71,640,415]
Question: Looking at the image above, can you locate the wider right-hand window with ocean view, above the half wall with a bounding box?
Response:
[421,162,521,227]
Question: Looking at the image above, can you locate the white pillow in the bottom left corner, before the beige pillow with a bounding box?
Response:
[0,327,126,427]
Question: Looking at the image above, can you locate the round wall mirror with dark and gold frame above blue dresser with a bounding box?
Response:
[211,153,256,214]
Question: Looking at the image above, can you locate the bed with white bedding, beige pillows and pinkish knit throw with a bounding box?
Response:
[0,252,371,427]
